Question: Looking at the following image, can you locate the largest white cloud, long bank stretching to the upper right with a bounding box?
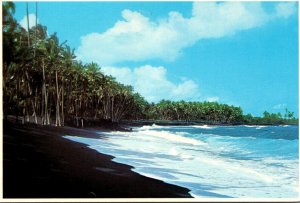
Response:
[76,2,296,65]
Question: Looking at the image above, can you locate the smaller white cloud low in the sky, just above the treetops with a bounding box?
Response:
[101,65,200,102]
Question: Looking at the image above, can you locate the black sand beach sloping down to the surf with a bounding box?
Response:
[3,122,191,198]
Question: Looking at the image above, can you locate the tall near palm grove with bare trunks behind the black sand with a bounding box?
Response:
[2,2,148,126]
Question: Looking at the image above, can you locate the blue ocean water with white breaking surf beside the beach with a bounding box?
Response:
[65,125,299,198]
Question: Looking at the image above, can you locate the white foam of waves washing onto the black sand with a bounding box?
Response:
[62,125,299,198]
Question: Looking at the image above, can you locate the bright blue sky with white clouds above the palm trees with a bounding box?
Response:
[15,2,298,116]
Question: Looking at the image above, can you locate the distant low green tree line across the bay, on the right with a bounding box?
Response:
[138,100,298,125]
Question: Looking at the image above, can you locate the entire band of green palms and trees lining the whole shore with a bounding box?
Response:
[2,2,298,126]
